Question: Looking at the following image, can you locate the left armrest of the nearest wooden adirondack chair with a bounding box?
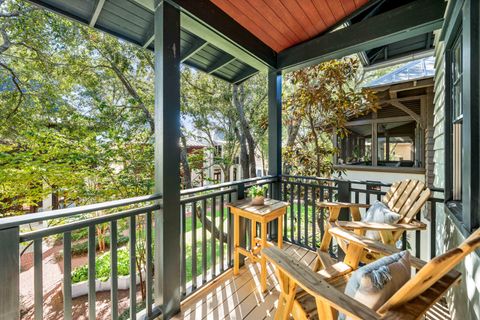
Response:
[262,247,381,319]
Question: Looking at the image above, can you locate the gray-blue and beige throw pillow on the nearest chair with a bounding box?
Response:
[338,251,411,320]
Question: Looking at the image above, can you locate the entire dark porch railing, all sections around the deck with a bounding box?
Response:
[0,175,443,319]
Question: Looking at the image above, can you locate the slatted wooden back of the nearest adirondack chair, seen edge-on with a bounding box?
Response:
[378,229,480,314]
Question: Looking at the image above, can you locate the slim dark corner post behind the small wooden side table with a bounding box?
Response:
[268,70,283,240]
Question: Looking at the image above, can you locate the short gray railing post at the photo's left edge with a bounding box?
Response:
[0,227,20,320]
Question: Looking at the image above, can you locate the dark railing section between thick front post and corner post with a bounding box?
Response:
[180,177,276,297]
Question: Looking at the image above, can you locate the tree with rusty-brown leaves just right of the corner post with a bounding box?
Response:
[283,57,378,176]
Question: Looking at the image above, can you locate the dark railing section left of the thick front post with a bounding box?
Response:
[0,195,161,319]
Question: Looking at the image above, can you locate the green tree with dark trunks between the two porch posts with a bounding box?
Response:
[181,68,268,181]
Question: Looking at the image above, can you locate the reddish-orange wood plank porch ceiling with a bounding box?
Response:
[211,0,368,52]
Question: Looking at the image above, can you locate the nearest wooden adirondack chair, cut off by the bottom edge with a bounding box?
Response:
[262,227,480,320]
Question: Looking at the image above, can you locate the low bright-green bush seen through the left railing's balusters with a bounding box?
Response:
[72,247,130,283]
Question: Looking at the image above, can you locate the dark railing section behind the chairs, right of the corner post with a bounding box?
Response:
[280,175,443,258]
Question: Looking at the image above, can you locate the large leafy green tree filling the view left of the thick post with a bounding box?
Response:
[0,0,154,215]
